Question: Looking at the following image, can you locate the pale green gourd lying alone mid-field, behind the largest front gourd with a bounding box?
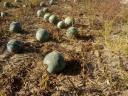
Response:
[36,28,50,42]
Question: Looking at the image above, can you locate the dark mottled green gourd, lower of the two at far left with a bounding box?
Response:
[7,39,23,53]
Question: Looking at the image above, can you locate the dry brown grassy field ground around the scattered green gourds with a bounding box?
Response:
[0,0,128,96]
